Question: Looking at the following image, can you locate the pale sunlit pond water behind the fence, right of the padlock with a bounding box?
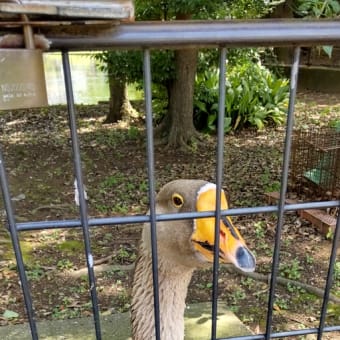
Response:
[44,52,109,105]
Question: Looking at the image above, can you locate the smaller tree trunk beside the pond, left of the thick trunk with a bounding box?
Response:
[104,77,134,124]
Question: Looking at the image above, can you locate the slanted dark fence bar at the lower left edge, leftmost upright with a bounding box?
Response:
[0,149,38,340]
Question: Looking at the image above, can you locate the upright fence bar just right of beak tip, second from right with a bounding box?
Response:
[265,46,300,339]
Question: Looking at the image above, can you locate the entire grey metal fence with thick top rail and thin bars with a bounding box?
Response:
[0,21,340,340]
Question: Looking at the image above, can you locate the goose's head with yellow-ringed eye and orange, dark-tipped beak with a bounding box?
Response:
[142,179,255,272]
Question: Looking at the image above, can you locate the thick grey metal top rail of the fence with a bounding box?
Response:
[46,19,340,51]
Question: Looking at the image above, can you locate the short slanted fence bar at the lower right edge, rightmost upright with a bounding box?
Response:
[318,211,340,340]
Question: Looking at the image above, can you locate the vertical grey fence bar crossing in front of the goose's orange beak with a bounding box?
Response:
[211,47,227,340]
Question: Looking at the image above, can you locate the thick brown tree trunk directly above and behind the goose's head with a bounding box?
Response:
[167,49,198,147]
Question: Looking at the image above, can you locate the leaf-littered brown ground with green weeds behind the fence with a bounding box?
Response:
[0,93,340,339]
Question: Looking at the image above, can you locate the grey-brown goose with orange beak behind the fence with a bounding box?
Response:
[131,179,255,340]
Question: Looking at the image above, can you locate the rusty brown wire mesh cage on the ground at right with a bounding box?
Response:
[291,127,340,197]
